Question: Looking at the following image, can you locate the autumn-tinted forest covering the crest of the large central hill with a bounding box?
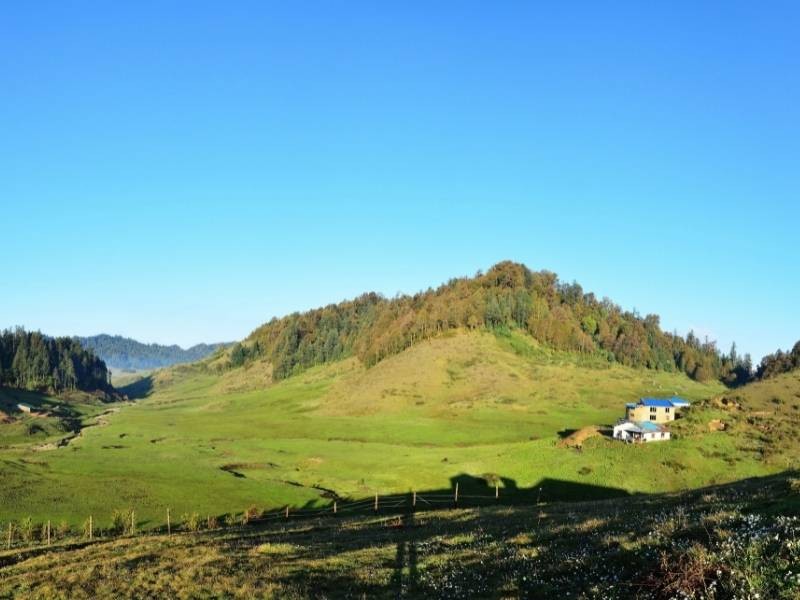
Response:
[242,262,750,383]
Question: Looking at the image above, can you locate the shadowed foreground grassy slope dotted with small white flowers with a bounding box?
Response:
[0,474,800,600]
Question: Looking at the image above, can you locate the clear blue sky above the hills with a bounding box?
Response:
[0,1,800,359]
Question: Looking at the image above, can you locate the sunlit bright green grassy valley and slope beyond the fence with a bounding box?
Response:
[0,333,788,525]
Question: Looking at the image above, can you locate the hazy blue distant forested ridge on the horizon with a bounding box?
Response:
[77,334,226,369]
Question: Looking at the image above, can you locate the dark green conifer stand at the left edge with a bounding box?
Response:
[0,328,111,392]
